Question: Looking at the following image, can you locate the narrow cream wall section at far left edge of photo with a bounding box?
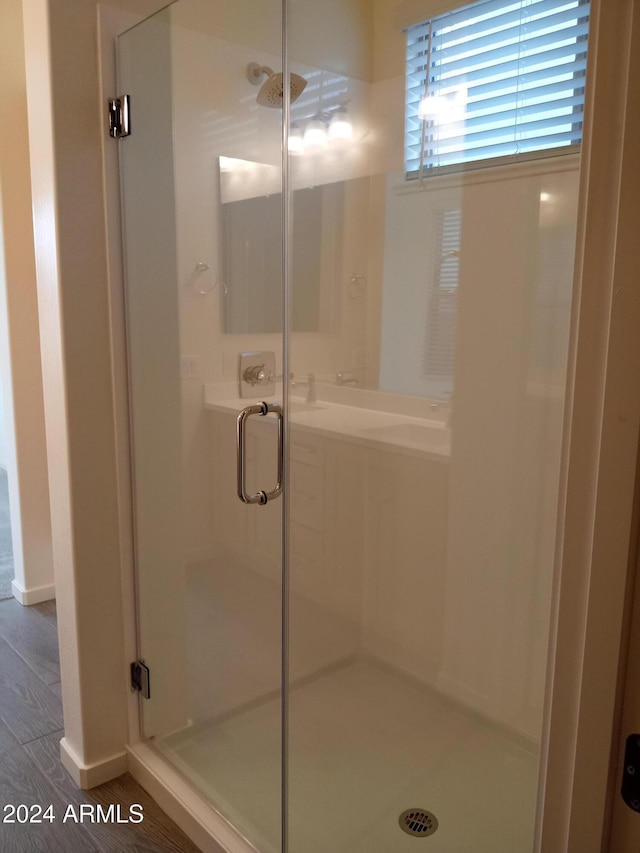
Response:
[0,0,54,604]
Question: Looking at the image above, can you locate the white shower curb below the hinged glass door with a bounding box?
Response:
[127,743,257,853]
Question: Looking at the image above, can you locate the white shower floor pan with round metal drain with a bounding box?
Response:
[156,661,538,853]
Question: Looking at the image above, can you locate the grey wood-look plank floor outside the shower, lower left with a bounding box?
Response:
[0,599,198,853]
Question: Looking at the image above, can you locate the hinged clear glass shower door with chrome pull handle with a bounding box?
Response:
[118,0,282,853]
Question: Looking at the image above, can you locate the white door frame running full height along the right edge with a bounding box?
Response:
[541,0,640,853]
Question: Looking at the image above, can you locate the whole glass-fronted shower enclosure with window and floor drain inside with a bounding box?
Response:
[117,0,589,853]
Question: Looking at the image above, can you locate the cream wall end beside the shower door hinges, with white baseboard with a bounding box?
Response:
[23,0,166,785]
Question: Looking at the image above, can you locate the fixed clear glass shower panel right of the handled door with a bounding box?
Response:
[287,0,579,853]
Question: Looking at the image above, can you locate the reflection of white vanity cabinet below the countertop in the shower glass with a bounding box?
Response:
[211,412,449,683]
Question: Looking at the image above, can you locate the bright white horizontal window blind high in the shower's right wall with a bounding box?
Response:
[405,0,589,177]
